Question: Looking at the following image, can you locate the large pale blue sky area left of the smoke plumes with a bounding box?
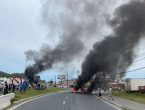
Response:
[0,0,46,72]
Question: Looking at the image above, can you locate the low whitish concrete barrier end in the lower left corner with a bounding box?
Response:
[0,93,15,110]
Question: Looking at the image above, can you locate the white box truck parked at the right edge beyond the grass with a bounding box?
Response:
[125,78,145,92]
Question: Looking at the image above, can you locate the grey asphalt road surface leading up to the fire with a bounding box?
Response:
[13,92,117,110]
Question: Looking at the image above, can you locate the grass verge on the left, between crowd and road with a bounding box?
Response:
[11,87,64,103]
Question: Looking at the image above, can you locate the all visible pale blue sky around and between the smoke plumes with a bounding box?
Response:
[0,0,145,80]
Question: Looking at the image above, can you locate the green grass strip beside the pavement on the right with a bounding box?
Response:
[113,91,145,104]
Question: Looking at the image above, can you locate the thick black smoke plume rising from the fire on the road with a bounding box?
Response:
[76,1,145,91]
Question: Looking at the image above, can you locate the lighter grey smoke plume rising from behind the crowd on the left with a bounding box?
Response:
[25,0,122,80]
